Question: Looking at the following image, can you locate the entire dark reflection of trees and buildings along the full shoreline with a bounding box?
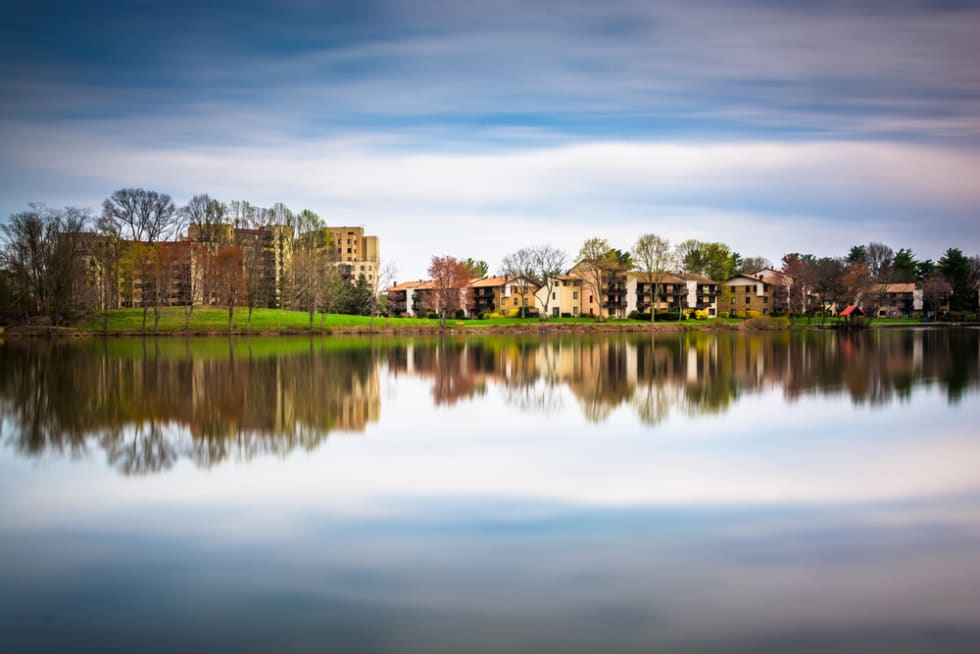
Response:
[0,329,980,474]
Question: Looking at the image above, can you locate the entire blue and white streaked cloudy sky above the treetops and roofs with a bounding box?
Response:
[0,0,980,280]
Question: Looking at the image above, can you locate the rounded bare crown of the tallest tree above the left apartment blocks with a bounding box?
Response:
[101,188,177,243]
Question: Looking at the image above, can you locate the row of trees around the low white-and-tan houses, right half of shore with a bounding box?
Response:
[428,233,980,322]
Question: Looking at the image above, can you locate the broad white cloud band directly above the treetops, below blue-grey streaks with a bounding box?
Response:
[3,128,980,278]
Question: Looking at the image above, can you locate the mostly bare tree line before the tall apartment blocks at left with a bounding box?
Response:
[0,188,393,330]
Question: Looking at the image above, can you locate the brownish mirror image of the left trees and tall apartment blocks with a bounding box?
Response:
[0,340,380,474]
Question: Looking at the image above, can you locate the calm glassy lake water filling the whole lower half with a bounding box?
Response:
[0,330,980,653]
